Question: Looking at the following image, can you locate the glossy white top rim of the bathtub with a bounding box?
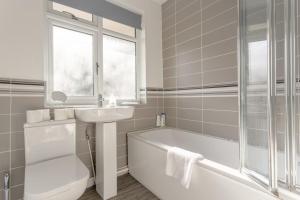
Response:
[127,127,299,200]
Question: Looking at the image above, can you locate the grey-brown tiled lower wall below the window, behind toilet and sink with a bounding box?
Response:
[0,80,163,200]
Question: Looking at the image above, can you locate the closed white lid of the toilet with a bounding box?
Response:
[25,155,89,199]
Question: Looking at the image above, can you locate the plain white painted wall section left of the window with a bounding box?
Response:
[0,0,43,80]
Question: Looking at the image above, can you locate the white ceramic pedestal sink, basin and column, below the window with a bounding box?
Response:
[75,106,134,200]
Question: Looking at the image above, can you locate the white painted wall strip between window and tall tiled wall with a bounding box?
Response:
[110,0,163,88]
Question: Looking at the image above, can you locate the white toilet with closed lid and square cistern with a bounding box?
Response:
[24,120,89,200]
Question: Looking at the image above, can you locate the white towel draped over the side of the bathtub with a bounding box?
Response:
[166,147,203,189]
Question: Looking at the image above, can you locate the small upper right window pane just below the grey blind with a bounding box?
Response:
[103,18,135,38]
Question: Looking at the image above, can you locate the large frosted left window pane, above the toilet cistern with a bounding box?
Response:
[53,26,94,96]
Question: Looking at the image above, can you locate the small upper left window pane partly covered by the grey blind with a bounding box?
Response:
[53,2,93,22]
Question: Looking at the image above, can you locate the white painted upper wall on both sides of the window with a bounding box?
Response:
[0,0,163,87]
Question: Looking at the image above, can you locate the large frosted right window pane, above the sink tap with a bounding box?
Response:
[103,35,136,100]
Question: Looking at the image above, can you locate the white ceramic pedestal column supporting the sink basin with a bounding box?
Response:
[96,122,117,200]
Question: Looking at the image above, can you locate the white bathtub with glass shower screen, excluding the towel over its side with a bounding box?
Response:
[128,129,297,200]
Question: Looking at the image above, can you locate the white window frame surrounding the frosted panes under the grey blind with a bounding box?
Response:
[44,1,142,107]
